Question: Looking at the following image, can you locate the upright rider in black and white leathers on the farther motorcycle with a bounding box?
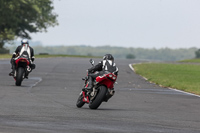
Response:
[9,39,35,78]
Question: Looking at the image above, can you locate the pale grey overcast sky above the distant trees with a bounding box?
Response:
[31,0,200,48]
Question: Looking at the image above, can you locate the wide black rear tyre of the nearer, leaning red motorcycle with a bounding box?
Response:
[89,86,107,109]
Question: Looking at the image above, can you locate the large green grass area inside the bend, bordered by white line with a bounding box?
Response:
[133,63,200,95]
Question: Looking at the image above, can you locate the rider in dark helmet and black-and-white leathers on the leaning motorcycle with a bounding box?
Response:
[83,54,118,90]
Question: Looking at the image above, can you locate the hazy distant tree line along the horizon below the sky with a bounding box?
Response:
[8,45,198,61]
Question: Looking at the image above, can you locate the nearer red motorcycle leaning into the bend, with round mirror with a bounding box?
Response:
[76,59,117,109]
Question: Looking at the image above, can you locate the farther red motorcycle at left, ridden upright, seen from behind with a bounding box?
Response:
[13,51,32,86]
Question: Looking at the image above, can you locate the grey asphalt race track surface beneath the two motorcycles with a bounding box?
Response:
[0,58,200,133]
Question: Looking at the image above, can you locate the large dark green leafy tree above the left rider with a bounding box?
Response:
[0,0,58,48]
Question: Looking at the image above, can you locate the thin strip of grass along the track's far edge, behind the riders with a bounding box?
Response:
[0,54,102,59]
